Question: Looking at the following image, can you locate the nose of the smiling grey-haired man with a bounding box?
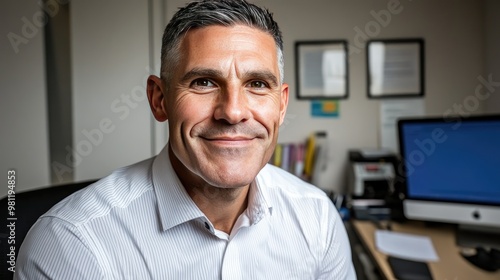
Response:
[214,86,250,124]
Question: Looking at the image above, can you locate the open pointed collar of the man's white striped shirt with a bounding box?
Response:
[152,144,272,231]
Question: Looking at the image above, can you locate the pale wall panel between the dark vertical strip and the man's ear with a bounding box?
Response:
[66,0,152,181]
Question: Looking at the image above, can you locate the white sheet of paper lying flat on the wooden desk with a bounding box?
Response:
[375,230,439,262]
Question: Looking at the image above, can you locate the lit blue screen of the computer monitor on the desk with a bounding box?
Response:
[399,118,500,205]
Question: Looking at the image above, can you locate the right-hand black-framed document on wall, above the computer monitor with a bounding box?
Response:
[366,39,425,98]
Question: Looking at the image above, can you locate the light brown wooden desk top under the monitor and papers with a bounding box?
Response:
[351,220,500,280]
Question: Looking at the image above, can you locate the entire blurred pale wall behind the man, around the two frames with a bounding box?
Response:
[0,0,500,196]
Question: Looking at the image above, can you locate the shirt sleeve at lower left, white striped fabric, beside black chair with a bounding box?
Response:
[14,217,104,280]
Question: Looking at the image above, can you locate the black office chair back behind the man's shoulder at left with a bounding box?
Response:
[0,180,97,279]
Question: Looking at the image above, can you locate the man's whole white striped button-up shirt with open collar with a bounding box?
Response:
[14,149,356,280]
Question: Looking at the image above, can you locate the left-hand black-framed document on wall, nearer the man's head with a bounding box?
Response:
[295,40,349,99]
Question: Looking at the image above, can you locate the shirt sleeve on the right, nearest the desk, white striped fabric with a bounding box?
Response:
[317,203,356,280]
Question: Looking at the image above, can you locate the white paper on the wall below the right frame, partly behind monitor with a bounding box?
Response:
[380,98,425,153]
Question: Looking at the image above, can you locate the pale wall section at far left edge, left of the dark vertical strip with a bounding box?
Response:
[0,0,49,197]
